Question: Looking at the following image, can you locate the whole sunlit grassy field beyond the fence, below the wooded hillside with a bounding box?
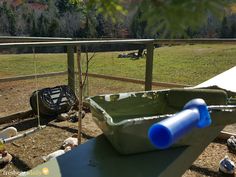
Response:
[0,45,236,85]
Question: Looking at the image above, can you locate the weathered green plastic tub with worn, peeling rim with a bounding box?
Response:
[89,89,227,154]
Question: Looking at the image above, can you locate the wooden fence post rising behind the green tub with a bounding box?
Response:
[145,43,154,91]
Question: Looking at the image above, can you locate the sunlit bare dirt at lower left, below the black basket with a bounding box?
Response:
[0,114,102,176]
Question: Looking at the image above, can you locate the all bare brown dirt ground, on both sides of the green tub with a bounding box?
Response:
[0,78,236,177]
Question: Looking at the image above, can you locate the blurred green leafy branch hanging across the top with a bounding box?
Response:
[70,0,236,37]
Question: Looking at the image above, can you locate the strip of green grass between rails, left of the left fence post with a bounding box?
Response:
[0,54,67,76]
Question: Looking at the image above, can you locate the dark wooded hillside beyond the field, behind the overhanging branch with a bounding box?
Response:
[0,0,236,38]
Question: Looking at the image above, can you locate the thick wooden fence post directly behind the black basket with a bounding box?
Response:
[67,46,75,91]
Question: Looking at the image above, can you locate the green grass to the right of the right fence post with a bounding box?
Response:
[153,45,236,84]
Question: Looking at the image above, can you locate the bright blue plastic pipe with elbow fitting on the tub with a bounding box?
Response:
[148,99,211,149]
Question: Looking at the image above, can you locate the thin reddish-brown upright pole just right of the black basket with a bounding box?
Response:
[76,46,83,144]
